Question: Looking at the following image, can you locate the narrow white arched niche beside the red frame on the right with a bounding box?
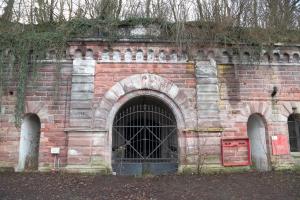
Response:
[247,114,270,171]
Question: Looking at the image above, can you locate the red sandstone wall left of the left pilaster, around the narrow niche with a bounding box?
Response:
[0,63,72,170]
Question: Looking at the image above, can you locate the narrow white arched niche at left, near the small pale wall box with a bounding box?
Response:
[18,113,41,171]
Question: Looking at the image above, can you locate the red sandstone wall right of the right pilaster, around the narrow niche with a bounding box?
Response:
[218,63,300,166]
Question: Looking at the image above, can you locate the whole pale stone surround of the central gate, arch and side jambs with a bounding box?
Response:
[92,74,197,168]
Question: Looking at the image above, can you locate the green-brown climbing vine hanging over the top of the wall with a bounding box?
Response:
[0,17,300,126]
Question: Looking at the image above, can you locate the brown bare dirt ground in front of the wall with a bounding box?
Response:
[0,172,300,200]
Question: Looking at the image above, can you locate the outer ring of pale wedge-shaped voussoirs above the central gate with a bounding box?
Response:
[93,74,192,128]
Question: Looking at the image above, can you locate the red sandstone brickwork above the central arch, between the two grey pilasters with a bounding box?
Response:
[95,63,196,104]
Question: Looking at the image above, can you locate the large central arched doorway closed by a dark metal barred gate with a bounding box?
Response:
[112,96,178,175]
